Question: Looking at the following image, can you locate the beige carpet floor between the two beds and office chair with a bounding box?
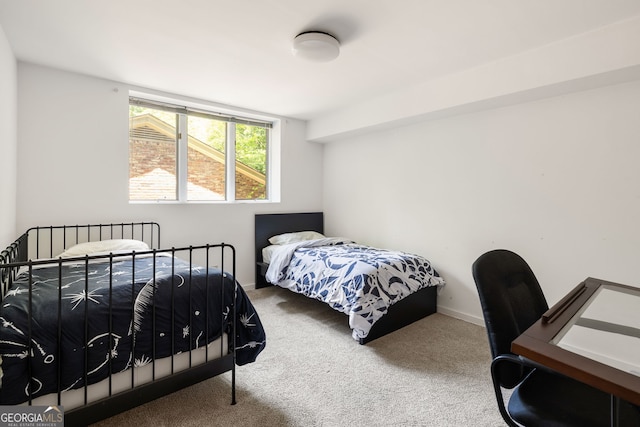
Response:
[95,287,504,427]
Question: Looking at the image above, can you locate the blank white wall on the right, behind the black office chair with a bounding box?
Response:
[324,81,640,323]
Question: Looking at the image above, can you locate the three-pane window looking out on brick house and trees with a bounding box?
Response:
[129,97,272,202]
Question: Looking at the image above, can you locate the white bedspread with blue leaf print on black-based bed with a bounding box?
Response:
[266,241,445,340]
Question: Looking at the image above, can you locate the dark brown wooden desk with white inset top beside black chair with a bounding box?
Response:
[511,278,640,405]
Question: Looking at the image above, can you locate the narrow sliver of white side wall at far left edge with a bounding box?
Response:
[0,27,18,249]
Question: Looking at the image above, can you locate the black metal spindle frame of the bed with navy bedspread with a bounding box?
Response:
[0,222,236,426]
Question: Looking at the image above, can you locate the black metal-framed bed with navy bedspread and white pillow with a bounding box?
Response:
[0,222,265,426]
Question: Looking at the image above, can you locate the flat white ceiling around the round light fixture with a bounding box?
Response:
[0,0,640,127]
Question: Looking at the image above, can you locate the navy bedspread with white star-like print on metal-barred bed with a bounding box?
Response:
[0,256,265,404]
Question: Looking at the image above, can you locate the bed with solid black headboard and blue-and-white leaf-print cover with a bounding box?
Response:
[255,212,444,344]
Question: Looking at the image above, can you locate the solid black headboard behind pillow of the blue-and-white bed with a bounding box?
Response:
[255,212,324,263]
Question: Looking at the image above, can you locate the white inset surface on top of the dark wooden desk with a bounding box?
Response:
[557,287,640,376]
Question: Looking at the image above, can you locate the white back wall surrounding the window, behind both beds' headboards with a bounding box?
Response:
[17,63,323,285]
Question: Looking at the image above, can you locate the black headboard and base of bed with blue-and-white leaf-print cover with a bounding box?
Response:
[255,212,438,344]
